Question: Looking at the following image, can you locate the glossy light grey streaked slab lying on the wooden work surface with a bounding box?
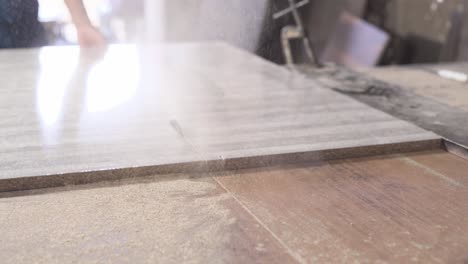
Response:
[0,43,439,190]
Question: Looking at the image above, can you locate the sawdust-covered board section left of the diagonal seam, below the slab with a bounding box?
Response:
[0,175,294,264]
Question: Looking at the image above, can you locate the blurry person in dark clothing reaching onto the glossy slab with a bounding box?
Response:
[0,0,105,48]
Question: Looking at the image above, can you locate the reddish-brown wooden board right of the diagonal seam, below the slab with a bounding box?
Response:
[216,152,468,263]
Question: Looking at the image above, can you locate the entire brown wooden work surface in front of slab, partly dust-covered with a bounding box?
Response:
[0,151,468,263]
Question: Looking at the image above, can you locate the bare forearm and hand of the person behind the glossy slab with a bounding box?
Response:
[64,0,106,47]
